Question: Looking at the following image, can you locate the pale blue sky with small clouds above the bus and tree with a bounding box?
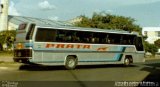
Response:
[6,0,160,27]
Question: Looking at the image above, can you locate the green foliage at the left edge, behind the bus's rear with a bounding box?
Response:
[0,30,16,50]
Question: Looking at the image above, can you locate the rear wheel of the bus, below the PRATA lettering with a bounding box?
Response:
[65,56,78,70]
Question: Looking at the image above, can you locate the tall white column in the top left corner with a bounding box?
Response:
[0,0,9,31]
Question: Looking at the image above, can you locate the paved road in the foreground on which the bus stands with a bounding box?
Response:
[0,59,160,87]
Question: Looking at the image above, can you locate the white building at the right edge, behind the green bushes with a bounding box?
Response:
[142,27,160,52]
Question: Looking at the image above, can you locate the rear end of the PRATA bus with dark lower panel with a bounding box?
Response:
[13,23,35,63]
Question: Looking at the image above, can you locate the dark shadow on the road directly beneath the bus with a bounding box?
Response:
[19,64,137,71]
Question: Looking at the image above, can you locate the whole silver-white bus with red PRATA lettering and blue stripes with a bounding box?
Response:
[14,23,144,69]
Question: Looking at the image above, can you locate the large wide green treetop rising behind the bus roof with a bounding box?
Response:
[75,12,141,32]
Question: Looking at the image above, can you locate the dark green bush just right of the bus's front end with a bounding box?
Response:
[144,41,158,55]
